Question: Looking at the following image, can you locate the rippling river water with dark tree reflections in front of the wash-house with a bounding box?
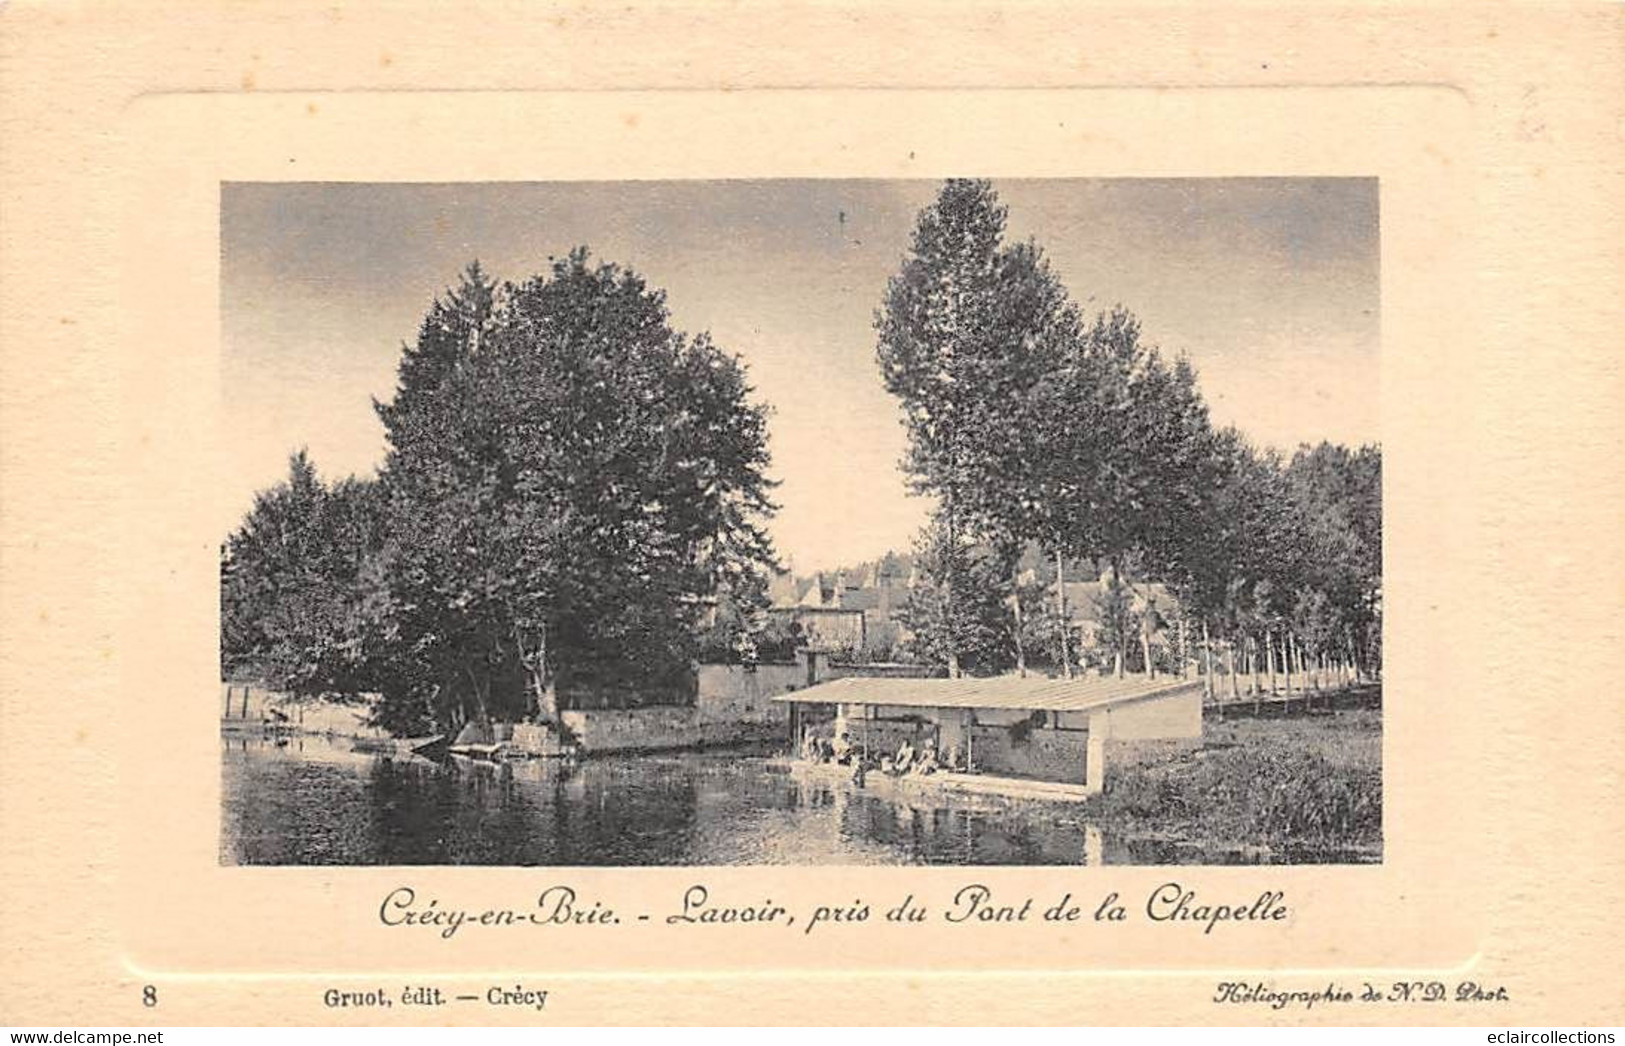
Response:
[221,737,1170,866]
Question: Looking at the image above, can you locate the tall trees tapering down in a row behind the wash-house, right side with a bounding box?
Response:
[876,180,1381,685]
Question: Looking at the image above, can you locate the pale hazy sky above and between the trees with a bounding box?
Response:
[221,179,1380,572]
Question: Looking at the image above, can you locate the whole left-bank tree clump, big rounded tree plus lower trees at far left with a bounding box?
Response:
[221,249,775,733]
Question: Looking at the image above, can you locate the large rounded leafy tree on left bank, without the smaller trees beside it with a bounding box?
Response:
[379,249,774,723]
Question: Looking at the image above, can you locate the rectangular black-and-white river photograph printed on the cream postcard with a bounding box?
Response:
[216,177,1383,866]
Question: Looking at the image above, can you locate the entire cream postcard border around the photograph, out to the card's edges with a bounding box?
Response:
[0,2,1625,1025]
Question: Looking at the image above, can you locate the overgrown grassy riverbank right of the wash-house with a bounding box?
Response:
[1087,695,1383,864]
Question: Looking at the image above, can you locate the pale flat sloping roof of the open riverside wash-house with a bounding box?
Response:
[774,676,1203,711]
